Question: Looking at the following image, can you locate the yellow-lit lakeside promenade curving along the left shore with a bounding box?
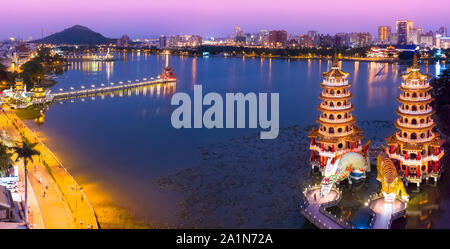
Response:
[0,107,98,229]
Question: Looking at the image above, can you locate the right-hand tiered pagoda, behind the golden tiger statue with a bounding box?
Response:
[386,55,444,186]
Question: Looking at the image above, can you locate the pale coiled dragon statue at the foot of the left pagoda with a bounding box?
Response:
[321,141,370,196]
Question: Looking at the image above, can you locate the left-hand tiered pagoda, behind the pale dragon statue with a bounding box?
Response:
[308,57,363,169]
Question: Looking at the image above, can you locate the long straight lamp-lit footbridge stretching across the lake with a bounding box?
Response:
[51,78,176,100]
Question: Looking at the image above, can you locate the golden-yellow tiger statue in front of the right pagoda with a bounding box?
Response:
[377,152,409,203]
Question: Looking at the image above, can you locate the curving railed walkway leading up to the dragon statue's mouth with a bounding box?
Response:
[300,185,353,229]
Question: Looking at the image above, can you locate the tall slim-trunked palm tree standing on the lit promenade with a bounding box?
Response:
[12,138,40,225]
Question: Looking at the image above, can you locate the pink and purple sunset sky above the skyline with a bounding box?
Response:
[0,0,450,39]
